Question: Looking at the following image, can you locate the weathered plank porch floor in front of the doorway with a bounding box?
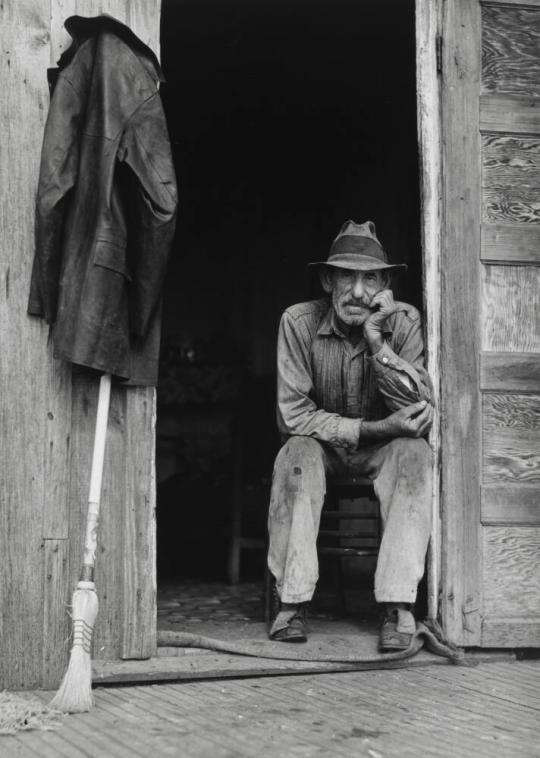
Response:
[5,661,540,758]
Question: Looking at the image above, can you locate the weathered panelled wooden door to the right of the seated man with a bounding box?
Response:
[441,0,540,647]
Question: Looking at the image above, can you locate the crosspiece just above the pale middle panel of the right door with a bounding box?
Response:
[480,224,540,263]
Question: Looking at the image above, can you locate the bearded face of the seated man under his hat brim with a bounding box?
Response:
[323,268,389,327]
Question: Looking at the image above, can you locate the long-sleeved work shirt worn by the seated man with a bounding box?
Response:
[277,298,432,449]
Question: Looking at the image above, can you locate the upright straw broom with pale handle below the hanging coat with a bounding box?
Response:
[51,374,111,713]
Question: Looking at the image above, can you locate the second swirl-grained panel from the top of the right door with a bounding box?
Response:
[482,134,540,225]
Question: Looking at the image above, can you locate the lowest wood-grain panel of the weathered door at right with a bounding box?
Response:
[482,526,540,620]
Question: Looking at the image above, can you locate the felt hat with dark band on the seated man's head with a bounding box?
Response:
[308,221,407,271]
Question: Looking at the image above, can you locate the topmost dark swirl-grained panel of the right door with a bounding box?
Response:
[482,3,540,97]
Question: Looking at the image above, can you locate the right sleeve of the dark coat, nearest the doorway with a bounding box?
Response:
[118,92,177,336]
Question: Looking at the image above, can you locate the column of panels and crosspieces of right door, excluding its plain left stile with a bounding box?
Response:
[480,3,540,646]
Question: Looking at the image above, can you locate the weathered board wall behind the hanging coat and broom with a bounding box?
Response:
[0,0,160,688]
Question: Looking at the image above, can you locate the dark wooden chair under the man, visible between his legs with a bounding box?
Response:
[264,476,381,625]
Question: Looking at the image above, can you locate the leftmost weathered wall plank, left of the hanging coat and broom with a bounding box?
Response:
[0,0,66,688]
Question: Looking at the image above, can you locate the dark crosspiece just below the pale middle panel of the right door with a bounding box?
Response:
[480,353,540,393]
